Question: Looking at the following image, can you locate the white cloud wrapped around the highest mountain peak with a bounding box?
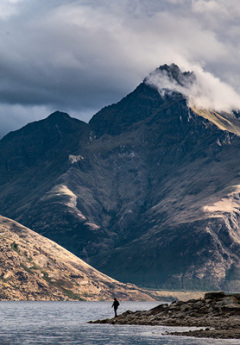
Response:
[146,64,240,112]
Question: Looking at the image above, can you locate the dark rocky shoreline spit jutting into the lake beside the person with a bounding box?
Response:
[90,292,240,339]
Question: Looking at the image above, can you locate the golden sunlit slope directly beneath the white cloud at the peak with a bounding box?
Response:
[191,106,240,136]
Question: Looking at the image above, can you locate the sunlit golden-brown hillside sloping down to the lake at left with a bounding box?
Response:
[0,217,156,301]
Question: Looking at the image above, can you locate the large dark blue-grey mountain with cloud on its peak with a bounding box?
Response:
[0,65,240,290]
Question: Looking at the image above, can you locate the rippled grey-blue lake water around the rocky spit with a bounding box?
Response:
[0,302,240,345]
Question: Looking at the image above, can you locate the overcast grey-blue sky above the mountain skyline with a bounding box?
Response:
[0,0,240,136]
